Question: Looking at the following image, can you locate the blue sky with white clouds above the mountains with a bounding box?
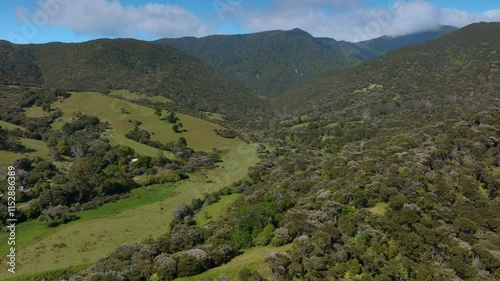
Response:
[0,0,500,44]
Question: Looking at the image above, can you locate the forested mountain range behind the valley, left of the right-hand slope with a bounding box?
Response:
[0,27,453,103]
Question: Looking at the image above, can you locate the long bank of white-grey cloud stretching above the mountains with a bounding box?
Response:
[16,0,500,42]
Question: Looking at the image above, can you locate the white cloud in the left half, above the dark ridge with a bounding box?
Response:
[20,0,209,37]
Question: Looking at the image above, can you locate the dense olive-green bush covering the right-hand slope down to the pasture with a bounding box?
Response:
[0,23,500,281]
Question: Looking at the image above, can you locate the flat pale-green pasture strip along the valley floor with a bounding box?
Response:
[0,138,258,280]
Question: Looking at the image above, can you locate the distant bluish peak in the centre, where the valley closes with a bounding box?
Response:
[156,29,357,96]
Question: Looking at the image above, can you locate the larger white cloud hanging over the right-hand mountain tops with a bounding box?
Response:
[243,0,500,42]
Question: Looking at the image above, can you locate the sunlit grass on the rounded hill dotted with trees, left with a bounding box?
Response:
[52,93,240,152]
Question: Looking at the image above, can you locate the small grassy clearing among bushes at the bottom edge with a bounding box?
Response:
[175,244,292,281]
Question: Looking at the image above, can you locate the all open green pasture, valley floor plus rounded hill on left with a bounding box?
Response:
[0,92,258,280]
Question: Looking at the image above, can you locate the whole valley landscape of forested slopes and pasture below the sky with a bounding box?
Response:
[0,20,500,281]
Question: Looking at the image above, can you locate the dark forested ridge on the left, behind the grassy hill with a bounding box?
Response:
[0,39,263,113]
